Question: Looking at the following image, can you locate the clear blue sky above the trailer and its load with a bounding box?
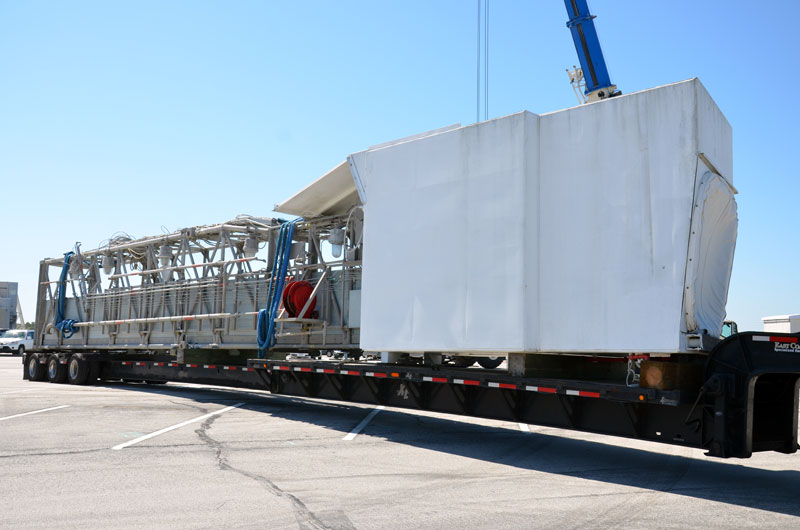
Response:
[0,0,800,329]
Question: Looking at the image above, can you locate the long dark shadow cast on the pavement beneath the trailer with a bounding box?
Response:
[95,383,800,516]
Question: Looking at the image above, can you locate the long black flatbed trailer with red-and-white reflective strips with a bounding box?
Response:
[23,332,800,458]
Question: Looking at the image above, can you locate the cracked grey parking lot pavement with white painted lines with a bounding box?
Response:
[0,355,800,530]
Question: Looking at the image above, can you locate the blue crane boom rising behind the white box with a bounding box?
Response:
[564,0,620,101]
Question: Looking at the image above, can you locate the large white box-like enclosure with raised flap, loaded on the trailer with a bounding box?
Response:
[277,79,737,355]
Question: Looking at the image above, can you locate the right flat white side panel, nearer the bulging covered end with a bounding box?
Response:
[539,79,696,352]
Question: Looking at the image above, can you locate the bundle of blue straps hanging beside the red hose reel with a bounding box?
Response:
[256,218,303,359]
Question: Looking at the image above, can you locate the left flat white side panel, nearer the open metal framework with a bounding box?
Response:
[358,113,536,351]
